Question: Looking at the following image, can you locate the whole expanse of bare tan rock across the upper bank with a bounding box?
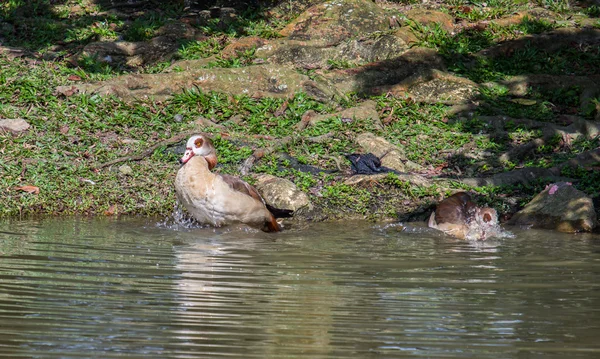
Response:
[58,0,477,104]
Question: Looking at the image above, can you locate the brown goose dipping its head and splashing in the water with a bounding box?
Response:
[428,192,498,240]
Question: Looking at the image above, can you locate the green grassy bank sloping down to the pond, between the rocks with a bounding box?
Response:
[0,0,600,219]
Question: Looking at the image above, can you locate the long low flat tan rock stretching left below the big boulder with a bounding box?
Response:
[57,65,337,101]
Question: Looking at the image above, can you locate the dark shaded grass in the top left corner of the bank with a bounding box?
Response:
[0,0,268,55]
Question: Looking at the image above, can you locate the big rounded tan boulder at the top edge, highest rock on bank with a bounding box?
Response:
[256,0,416,69]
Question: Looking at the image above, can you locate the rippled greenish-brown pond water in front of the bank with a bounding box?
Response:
[0,219,600,358]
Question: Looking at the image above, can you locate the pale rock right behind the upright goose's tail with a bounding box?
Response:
[255,174,312,213]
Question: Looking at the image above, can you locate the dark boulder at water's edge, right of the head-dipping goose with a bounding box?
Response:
[508,182,596,233]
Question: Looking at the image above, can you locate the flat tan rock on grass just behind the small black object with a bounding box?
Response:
[355,132,422,172]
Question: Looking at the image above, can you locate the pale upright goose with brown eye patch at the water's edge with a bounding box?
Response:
[175,135,291,232]
